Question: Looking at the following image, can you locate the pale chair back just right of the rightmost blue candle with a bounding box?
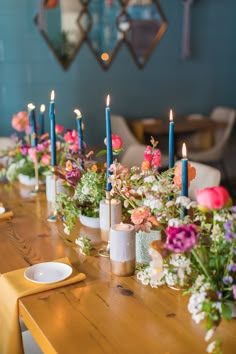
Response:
[188,161,221,200]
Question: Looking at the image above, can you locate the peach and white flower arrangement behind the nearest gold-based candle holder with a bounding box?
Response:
[110,138,195,232]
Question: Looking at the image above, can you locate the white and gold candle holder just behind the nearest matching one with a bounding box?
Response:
[99,199,122,242]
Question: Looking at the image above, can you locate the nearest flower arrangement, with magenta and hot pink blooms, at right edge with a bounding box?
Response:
[138,186,236,354]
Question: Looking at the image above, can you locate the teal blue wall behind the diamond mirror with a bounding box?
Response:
[0,0,236,144]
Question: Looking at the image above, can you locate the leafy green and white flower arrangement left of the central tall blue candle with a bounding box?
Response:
[56,134,122,234]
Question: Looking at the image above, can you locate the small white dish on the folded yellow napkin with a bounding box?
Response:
[24,262,72,284]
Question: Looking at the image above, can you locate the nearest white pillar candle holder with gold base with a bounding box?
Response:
[110,223,136,276]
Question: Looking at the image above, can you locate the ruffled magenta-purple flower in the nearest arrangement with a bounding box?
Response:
[165,224,198,253]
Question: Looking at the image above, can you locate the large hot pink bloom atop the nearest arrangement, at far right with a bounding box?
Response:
[195,186,230,209]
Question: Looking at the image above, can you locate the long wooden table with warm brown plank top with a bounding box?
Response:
[0,185,236,354]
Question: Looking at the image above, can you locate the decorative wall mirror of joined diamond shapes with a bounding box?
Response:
[35,0,167,69]
